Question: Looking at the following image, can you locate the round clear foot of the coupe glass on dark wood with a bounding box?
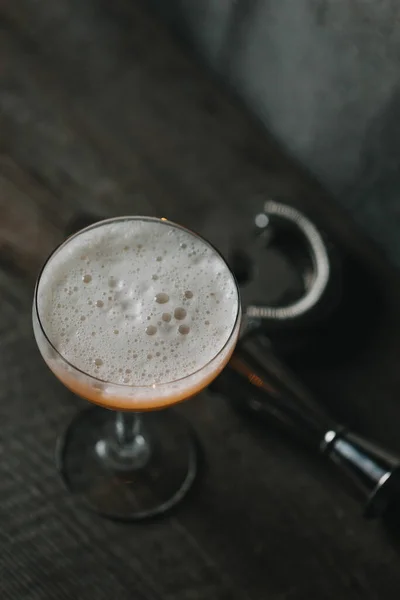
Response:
[56,406,198,521]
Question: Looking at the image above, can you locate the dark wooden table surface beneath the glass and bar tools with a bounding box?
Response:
[0,0,400,600]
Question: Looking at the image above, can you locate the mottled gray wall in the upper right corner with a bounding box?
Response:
[150,0,400,266]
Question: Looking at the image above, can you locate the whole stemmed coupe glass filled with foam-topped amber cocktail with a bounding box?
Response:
[33,217,241,520]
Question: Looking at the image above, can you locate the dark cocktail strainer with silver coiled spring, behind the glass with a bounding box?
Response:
[228,200,384,370]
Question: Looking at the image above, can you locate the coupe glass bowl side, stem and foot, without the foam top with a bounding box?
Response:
[33,217,241,521]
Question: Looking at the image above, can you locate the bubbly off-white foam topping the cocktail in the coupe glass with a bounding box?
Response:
[37,218,239,408]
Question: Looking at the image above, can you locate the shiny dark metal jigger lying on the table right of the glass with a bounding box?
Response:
[211,331,400,517]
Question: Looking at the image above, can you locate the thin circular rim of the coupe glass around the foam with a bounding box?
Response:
[34,215,242,390]
